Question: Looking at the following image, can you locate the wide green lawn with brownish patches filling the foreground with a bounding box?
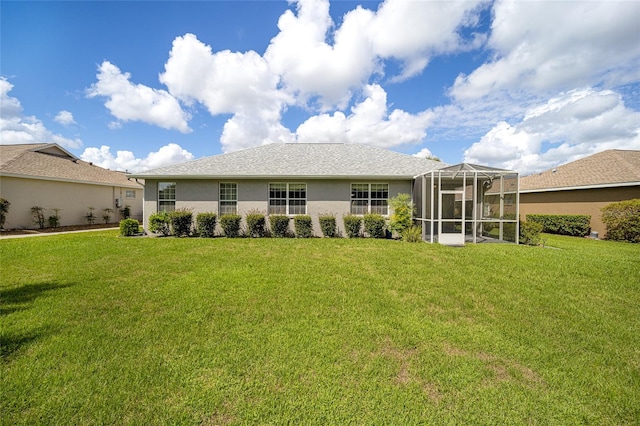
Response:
[0,231,640,425]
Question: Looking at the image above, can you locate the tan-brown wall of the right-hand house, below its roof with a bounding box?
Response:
[520,186,640,238]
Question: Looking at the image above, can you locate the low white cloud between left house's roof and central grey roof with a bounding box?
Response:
[80,143,193,172]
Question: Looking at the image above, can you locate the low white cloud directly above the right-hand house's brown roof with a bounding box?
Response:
[464,89,640,174]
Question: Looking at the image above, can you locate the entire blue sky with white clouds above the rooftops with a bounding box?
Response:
[0,0,640,174]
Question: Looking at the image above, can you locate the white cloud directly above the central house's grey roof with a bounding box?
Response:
[296,84,433,148]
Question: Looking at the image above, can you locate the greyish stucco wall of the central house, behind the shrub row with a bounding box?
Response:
[144,179,412,235]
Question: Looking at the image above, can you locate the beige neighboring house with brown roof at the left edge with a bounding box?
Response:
[0,144,142,229]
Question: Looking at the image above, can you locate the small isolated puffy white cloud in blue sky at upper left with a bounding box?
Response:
[87,61,191,133]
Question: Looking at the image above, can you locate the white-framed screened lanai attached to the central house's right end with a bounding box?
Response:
[414,163,519,245]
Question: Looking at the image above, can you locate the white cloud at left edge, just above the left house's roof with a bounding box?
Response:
[0,77,82,148]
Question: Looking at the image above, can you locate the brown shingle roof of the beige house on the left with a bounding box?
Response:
[0,143,142,188]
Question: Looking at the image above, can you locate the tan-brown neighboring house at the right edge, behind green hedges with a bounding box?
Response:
[520,149,640,237]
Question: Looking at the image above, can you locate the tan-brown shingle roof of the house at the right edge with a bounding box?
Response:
[520,149,640,192]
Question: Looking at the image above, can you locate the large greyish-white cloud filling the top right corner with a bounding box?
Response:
[451,0,640,100]
